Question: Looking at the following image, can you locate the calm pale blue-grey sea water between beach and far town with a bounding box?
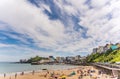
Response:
[0,62,78,74]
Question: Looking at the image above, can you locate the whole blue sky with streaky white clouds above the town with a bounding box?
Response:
[0,0,120,61]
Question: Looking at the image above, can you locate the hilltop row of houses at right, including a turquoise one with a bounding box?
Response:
[92,43,120,53]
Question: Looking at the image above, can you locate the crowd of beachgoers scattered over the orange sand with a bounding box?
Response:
[4,67,118,79]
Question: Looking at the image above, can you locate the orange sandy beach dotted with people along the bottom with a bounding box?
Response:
[0,66,116,79]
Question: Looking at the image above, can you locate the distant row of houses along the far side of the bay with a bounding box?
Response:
[32,55,85,65]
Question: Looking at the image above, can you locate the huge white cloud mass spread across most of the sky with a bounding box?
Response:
[0,0,120,59]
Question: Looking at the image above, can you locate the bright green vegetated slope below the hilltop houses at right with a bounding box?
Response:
[87,50,120,63]
